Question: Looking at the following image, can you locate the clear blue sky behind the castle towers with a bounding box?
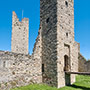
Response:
[0,0,90,59]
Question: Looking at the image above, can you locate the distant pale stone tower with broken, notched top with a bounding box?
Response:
[11,12,29,54]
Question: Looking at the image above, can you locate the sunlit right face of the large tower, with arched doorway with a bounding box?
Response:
[57,0,79,87]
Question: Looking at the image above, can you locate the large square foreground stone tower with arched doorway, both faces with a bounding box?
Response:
[40,0,79,88]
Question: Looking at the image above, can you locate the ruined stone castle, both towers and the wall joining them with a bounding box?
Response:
[0,0,85,90]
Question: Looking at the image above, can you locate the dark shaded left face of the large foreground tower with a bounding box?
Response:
[40,0,57,87]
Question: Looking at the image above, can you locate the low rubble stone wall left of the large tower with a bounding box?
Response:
[0,51,42,90]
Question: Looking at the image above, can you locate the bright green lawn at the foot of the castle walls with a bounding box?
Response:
[11,76,90,90]
